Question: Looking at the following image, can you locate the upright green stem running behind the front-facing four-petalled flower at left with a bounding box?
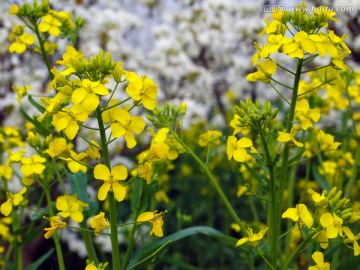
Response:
[96,107,120,270]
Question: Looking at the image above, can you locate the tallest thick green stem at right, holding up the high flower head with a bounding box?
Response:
[270,59,303,266]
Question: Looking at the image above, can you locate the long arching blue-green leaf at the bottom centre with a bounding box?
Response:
[127,226,222,268]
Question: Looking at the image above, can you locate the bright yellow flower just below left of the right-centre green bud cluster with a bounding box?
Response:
[226,136,253,162]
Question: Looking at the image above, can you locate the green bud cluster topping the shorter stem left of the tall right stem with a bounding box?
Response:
[236,98,279,132]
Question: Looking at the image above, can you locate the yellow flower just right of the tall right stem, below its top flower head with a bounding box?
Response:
[295,99,320,130]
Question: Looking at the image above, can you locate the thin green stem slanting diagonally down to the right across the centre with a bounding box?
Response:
[168,127,247,233]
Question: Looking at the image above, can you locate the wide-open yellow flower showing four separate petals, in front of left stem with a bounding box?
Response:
[94,164,128,202]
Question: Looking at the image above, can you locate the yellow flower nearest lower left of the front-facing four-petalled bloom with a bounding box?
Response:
[56,195,87,223]
